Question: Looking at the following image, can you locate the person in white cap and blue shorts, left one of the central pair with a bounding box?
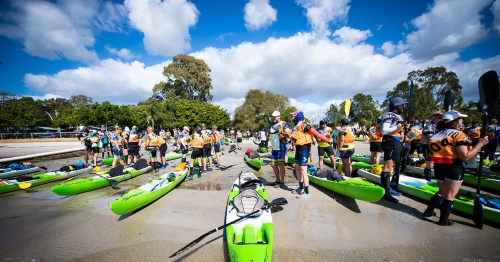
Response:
[269,111,291,188]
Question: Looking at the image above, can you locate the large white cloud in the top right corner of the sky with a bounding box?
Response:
[406,0,491,59]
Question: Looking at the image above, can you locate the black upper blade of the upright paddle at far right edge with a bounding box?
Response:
[478,70,499,114]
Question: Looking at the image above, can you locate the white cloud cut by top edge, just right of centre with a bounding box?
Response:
[295,0,350,38]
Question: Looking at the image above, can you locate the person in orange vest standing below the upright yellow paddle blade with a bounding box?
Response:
[336,118,354,177]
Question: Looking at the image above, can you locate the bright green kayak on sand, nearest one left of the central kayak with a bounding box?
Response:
[109,163,189,215]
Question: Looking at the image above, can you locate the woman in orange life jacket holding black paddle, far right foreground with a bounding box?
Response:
[422,110,488,226]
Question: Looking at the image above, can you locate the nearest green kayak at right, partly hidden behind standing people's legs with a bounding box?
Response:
[358,169,500,224]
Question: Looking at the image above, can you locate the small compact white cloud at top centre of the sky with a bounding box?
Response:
[244,0,278,31]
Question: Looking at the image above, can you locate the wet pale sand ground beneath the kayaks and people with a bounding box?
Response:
[0,141,500,261]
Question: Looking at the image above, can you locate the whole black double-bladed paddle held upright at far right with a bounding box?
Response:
[472,70,499,229]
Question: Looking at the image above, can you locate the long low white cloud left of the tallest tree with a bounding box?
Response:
[24,59,168,104]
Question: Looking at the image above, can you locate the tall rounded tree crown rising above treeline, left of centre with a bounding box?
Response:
[152,54,213,102]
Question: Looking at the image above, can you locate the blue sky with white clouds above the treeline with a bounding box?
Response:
[0,0,500,121]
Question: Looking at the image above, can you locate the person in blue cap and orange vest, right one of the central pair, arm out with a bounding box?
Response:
[291,110,330,199]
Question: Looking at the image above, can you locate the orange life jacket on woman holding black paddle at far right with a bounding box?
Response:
[428,129,472,164]
